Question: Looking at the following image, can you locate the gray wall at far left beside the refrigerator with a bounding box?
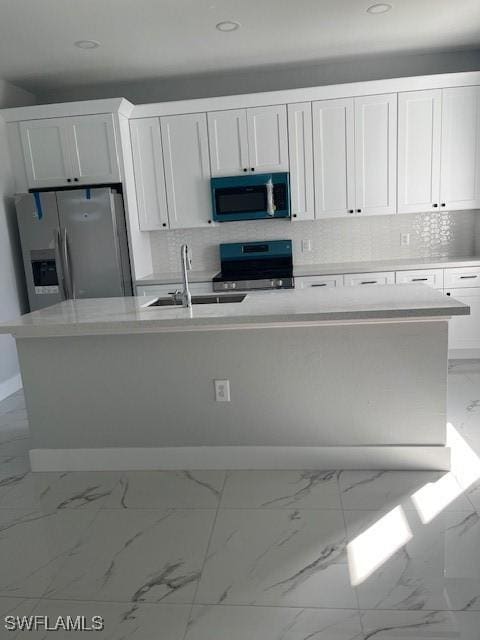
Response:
[0,79,35,392]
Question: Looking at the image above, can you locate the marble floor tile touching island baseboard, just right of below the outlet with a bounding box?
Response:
[220,470,341,509]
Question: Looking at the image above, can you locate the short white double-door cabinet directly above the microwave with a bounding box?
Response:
[208,105,289,176]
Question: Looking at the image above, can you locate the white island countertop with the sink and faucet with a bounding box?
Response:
[0,284,470,338]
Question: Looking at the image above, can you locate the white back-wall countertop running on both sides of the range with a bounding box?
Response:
[136,256,480,285]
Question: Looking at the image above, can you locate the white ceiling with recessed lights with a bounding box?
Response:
[0,0,480,91]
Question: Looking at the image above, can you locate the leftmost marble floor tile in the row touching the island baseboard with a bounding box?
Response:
[0,471,120,512]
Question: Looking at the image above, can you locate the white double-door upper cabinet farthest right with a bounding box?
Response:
[398,87,480,213]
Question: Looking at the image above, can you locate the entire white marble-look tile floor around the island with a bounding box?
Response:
[0,361,480,640]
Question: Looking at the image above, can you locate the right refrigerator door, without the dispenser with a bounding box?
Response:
[56,188,131,298]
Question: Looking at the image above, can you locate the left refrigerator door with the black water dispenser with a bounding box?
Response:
[15,192,65,311]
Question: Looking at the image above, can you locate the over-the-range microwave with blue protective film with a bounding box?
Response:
[211,172,291,222]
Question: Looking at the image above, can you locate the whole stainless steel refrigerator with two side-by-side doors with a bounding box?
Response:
[16,187,132,311]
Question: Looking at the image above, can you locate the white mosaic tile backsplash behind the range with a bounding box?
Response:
[150,211,480,273]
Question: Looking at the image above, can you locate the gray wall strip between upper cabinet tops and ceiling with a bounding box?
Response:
[37,49,480,104]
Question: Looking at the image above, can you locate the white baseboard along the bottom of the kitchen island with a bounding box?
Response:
[30,446,450,471]
